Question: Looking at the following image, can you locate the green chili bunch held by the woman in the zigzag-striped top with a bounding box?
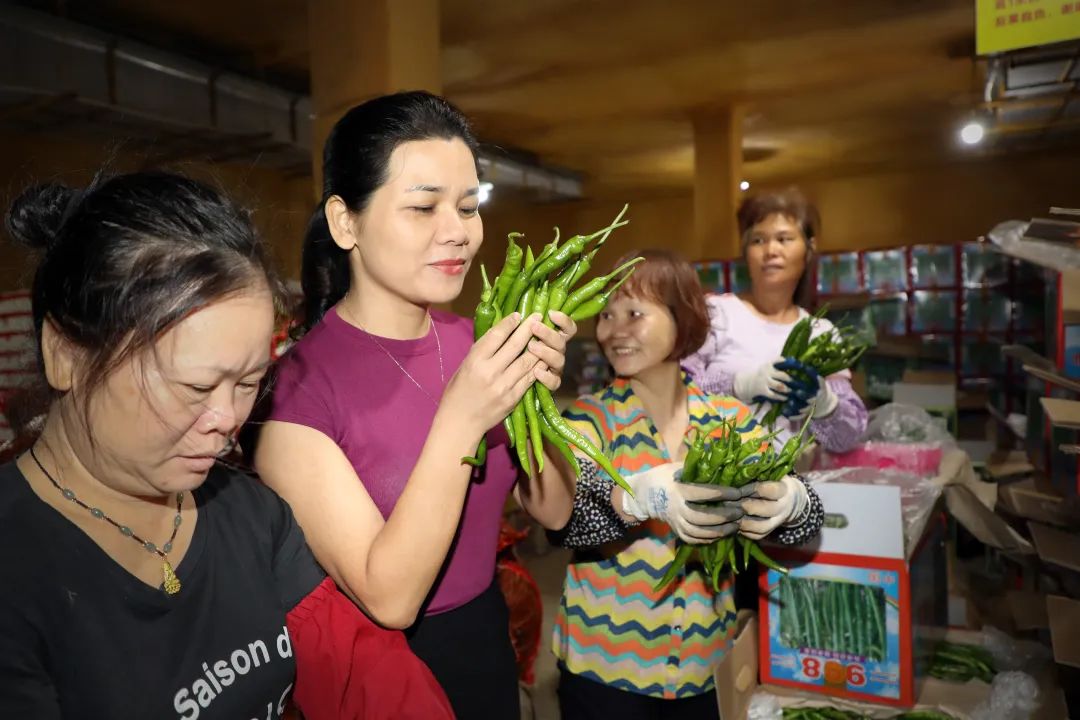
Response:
[656,414,810,590]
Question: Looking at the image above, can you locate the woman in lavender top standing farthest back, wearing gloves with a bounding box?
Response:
[684,189,866,452]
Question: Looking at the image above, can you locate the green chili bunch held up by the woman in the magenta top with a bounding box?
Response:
[462,206,644,491]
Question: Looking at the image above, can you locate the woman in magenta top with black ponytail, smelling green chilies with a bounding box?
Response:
[256,92,576,719]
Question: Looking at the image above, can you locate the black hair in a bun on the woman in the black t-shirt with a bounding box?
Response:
[5,172,282,427]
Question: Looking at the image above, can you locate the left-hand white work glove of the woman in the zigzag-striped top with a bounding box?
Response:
[622,463,743,544]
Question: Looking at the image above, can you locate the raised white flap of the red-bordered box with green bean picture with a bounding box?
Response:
[813,483,904,560]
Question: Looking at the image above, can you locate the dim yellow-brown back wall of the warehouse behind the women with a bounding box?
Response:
[0,134,1080,312]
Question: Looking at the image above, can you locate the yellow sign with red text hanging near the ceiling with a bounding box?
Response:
[975,0,1080,55]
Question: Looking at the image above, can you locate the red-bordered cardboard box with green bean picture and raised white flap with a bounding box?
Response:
[758,483,947,707]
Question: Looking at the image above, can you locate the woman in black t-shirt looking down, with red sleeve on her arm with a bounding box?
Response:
[0,173,448,720]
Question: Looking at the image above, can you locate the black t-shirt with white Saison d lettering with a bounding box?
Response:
[0,463,324,720]
